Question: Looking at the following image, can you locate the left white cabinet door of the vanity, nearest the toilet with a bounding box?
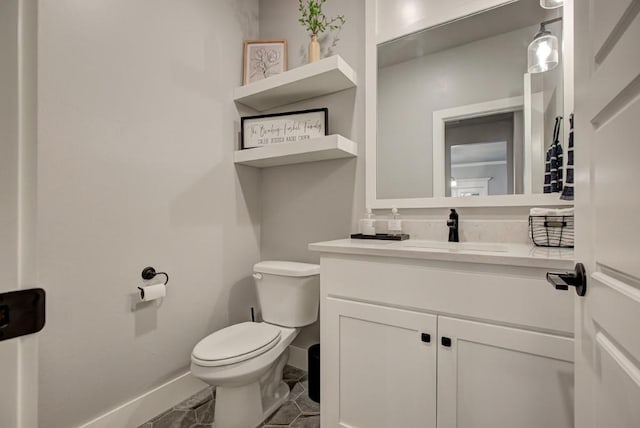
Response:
[320,298,437,428]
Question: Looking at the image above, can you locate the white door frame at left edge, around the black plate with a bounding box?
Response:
[0,0,38,428]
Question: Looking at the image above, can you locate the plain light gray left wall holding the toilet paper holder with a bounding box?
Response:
[38,0,260,428]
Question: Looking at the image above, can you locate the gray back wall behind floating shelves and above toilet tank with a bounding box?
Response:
[260,0,365,347]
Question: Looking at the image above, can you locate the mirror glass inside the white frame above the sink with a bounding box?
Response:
[376,0,563,200]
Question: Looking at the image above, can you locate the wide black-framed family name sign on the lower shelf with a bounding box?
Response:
[240,107,329,150]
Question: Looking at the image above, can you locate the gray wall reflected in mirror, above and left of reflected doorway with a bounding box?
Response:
[377,27,536,199]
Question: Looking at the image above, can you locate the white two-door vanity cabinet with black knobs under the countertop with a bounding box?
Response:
[310,240,573,428]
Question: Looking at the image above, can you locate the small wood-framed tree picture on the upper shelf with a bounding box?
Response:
[242,39,287,85]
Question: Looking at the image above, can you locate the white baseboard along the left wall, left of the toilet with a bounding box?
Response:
[79,372,207,428]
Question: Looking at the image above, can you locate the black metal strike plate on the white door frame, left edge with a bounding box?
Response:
[0,288,46,341]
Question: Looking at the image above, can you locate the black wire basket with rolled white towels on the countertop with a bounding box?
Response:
[529,215,575,248]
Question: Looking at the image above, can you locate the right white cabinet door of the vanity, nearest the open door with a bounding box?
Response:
[438,317,574,428]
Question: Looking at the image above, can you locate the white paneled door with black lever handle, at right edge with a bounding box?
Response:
[573,0,640,428]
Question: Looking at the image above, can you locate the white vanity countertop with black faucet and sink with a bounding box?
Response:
[309,239,574,269]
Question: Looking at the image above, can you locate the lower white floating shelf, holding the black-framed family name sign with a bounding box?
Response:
[233,135,358,168]
